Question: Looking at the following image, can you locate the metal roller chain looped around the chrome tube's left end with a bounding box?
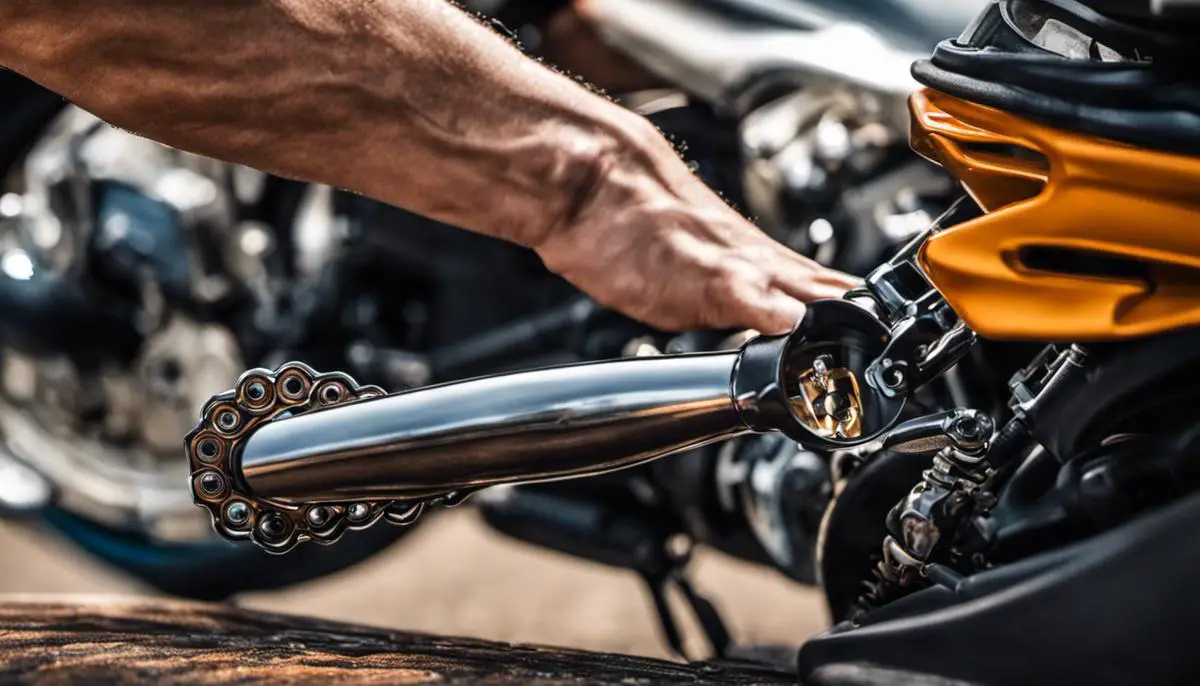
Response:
[184,362,464,554]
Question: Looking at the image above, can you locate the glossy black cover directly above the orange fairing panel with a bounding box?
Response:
[913,0,1200,155]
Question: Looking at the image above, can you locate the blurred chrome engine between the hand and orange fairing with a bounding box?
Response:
[737,78,954,273]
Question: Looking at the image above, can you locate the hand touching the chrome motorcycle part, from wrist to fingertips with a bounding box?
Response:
[535,146,860,333]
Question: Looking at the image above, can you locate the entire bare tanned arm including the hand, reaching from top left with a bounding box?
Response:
[0,0,856,332]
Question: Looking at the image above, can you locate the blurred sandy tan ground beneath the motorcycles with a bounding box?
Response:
[0,510,827,657]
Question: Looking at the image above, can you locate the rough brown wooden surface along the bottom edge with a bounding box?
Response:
[0,596,791,686]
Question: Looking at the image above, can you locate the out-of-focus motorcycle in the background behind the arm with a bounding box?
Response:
[0,0,965,600]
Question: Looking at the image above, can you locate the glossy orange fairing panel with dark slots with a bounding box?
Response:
[910,90,1200,342]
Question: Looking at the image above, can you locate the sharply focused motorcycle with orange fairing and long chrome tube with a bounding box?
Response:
[138,0,1200,684]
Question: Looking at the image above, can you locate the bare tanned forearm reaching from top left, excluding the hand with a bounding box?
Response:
[0,0,682,246]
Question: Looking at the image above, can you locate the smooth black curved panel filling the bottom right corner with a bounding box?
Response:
[799,495,1200,686]
